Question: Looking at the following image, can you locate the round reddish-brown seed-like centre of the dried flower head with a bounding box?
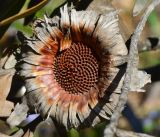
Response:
[54,44,98,94]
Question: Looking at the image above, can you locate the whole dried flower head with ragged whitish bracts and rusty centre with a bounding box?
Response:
[18,5,127,129]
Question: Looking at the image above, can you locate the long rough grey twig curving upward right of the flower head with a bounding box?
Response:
[104,0,160,137]
